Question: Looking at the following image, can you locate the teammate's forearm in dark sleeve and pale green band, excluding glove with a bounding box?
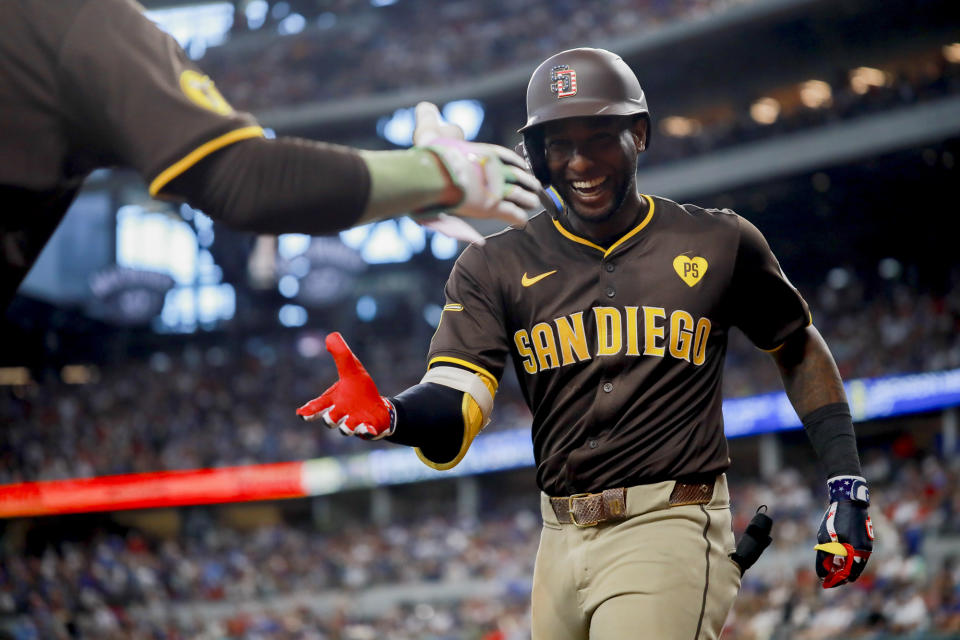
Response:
[164,138,462,234]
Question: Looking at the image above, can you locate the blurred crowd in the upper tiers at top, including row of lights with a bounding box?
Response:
[189,0,960,172]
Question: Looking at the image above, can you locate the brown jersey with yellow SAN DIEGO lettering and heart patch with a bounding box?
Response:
[429,196,809,496]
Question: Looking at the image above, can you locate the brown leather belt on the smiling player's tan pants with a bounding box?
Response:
[550,480,714,527]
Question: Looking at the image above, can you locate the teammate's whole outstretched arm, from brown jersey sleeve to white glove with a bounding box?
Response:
[58,0,539,239]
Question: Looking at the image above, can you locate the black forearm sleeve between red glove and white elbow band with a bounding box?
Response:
[387,382,463,463]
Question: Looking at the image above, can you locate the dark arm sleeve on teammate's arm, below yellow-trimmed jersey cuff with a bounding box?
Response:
[163,138,370,235]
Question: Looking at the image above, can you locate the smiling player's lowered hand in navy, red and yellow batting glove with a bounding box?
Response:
[814,476,874,589]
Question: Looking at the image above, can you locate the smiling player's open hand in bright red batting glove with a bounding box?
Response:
[297,332,396,440]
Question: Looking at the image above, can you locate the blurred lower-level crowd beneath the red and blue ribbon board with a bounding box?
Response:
[0,444,960,640]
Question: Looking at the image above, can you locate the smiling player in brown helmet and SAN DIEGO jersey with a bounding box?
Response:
[298,49,872,640]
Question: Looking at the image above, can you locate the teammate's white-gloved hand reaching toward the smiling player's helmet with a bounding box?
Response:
[413,102,541,224]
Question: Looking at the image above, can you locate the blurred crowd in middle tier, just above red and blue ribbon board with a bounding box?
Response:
[0,264,960,484]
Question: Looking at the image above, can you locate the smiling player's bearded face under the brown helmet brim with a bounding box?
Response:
[544,117,646,235]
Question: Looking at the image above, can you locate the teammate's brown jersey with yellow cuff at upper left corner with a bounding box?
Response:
[0,0,263,308]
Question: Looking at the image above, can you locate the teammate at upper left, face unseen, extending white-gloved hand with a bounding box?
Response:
[0,0,539,310]
